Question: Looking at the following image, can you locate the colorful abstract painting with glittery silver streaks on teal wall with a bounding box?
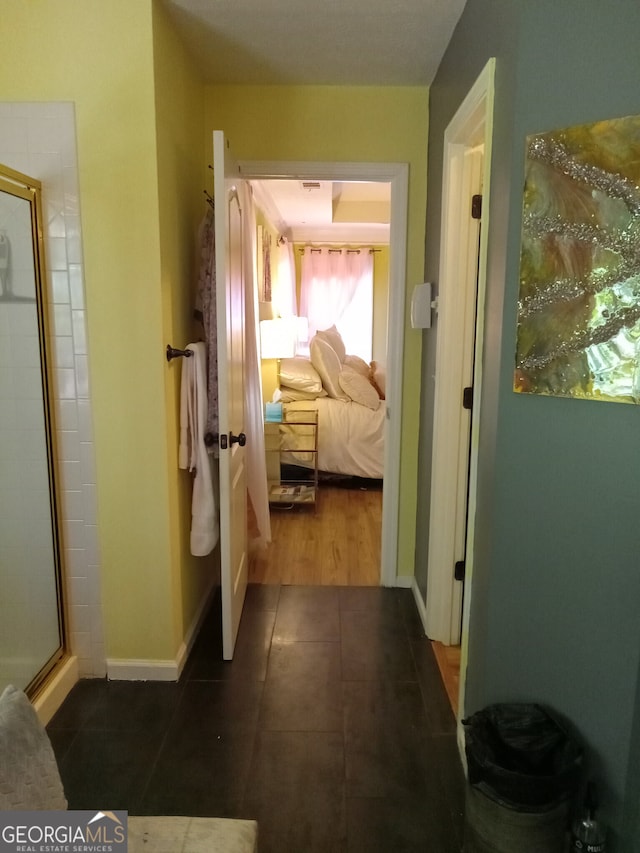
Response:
[514,116,640,403]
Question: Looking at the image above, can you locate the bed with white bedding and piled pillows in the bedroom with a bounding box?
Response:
[279,327,386,479]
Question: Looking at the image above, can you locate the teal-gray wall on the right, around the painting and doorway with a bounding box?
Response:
[416,0,640,853]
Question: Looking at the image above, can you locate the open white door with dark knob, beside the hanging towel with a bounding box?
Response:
[213,130,248,660]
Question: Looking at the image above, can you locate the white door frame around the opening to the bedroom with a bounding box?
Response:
[238,160,409,586]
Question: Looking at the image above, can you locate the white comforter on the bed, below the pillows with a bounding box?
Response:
[284,397,386,479]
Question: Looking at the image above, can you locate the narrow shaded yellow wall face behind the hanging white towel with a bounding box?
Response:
[153,4,214,648]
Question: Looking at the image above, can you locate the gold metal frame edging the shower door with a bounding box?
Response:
[0,164,69,699]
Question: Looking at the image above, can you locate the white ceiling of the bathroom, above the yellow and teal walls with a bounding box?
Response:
[164,0,466,86]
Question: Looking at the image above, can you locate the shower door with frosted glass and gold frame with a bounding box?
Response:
[0,166,65,694]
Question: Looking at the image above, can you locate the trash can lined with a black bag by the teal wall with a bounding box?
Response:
[463,703,582,853]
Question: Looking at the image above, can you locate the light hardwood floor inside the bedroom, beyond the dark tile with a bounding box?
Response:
[249,484,382,586]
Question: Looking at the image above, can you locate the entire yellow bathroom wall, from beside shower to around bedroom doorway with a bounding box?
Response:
[0,11,427,672]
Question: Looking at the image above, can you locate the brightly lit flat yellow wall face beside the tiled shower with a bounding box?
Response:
[0,0,190,659]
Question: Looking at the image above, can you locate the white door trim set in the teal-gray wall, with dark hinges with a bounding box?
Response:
[425,59,495,656]
